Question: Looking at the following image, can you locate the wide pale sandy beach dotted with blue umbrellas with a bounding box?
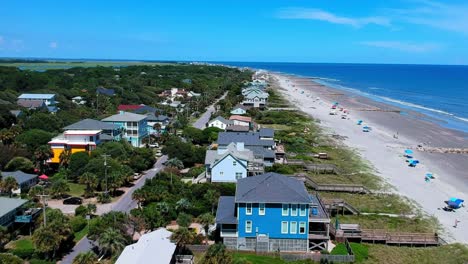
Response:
[273,74,468,243]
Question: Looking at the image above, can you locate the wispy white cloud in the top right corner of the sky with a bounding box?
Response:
[386,0,468,34]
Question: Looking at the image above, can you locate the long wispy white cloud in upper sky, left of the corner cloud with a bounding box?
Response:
[278,8,391,28]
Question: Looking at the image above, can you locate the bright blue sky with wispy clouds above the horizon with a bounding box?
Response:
[0,0,468,64]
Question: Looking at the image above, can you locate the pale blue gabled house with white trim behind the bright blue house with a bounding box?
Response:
[205,143,263,182]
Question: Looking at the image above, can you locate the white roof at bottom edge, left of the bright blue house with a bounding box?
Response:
[115,228,188,264]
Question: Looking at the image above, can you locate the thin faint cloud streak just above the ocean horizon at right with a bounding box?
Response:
[359,41,440,53]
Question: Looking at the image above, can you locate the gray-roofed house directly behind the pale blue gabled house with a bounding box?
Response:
[217,132,276,166]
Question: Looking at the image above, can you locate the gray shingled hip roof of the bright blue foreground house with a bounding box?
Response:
[236,172,312,204]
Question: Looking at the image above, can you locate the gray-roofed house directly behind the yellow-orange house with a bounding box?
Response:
[63,118,122,142]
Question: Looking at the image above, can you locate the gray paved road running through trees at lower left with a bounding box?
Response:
[60,155,167,264]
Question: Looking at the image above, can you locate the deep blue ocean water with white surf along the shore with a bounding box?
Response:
[221,62,468,132]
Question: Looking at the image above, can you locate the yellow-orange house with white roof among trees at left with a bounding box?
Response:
[48,130,102,163]
